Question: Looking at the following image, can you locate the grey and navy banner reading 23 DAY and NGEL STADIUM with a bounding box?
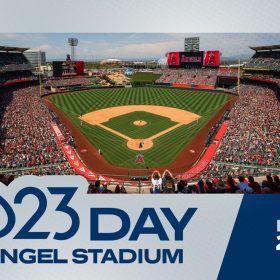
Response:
[0,176,280,280]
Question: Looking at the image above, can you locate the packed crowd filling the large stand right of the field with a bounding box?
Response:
[214,85,280,167]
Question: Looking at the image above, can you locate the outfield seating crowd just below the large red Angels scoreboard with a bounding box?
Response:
[155,69,218,86]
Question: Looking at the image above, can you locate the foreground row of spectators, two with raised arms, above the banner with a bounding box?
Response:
[87,170,280,194]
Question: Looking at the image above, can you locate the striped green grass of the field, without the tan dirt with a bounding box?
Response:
[50,88,228,168]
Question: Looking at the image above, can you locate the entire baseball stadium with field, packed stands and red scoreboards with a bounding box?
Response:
[0,38,280,194]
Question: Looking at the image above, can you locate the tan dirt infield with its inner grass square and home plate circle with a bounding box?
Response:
[80,105,200,151]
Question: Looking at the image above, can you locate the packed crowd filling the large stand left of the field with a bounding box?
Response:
[0,87,69,168]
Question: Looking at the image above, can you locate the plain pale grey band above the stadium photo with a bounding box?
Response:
[0,0,280,33]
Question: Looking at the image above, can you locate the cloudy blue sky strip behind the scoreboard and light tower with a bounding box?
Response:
[0,33,280,60]
